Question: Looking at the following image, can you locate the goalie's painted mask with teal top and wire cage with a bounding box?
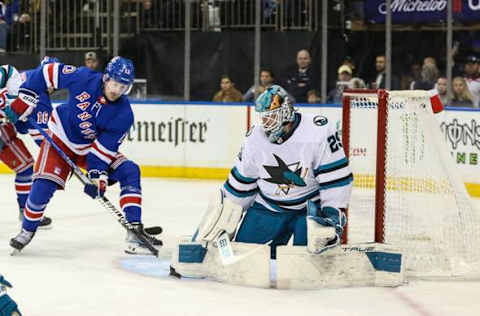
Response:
[255,85,295,143]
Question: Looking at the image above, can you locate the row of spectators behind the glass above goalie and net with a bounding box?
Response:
[213,40,480,108]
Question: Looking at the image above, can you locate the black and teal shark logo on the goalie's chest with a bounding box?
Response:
[263,154,308,195]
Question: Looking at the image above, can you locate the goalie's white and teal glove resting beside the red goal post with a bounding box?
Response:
[307,201,347,253]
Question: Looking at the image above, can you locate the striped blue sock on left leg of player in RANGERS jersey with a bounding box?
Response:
[22,179,57,232]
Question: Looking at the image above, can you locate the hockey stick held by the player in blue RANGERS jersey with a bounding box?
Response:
[28,117,158,257]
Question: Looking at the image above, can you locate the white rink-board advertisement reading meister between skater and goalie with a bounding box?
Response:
[121,104,247,168]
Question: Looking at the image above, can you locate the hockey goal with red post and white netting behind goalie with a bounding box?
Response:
[342,90,480,278]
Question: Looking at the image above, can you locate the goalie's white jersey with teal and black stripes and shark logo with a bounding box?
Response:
[224,113,353,212]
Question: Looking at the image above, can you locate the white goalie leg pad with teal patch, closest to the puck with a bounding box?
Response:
[171,236,270,288]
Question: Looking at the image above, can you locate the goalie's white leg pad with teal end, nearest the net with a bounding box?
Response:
[277,243,405,289]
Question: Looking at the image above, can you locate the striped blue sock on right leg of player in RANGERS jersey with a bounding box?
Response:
[110,160,142,223]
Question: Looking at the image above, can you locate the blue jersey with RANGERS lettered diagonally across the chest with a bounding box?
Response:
[21,63,133,170]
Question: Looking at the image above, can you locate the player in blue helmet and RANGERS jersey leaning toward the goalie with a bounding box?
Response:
[10,57,162,253]
